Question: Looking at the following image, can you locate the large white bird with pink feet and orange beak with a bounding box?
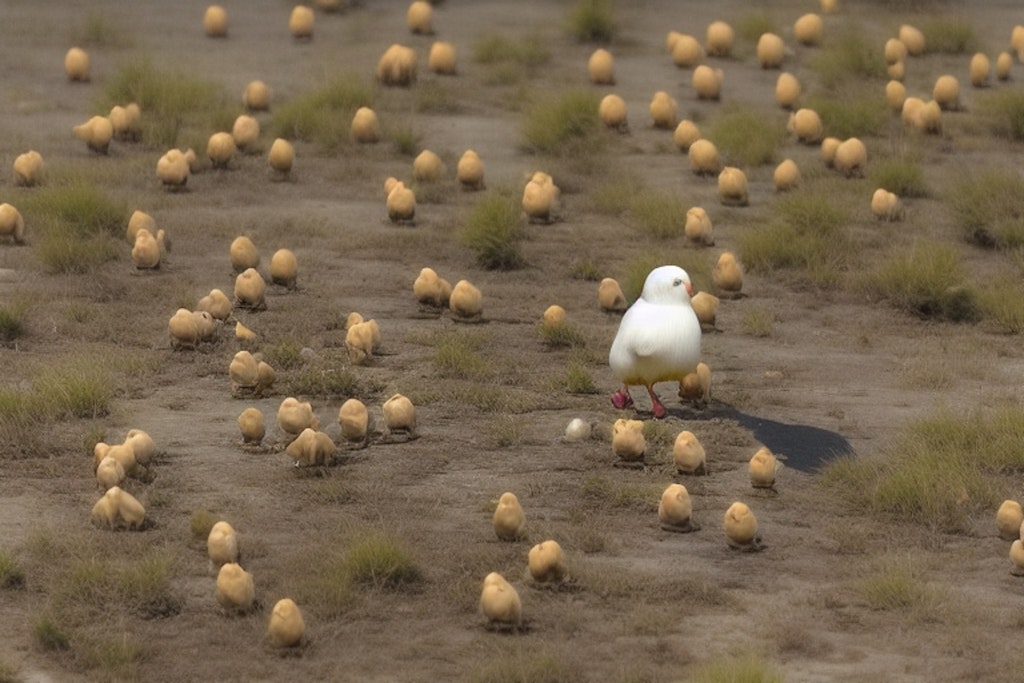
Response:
[608,265,700,418]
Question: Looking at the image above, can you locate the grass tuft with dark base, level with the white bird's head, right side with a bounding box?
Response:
[862,242,981,323]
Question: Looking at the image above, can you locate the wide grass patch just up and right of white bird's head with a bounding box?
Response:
[738,194,852,287]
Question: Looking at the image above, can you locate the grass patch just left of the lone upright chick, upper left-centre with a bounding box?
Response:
[270,74,374,152]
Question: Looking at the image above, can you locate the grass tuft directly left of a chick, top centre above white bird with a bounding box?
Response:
[522,88,606,158]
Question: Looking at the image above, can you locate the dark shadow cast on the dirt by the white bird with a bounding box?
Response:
[675,401,854,472]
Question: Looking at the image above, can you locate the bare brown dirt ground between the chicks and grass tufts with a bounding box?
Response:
[6,0,1024,682]
